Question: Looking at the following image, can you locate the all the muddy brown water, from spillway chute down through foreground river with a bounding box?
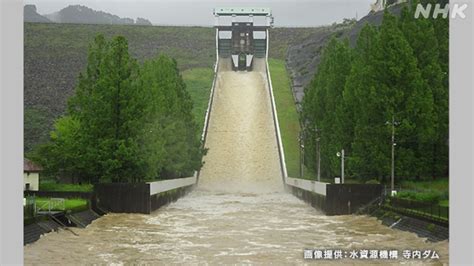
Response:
[24,59,448,265]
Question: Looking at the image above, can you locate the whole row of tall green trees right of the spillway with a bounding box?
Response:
[302,2,449,182]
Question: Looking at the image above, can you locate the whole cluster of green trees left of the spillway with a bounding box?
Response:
[31,35,204,183]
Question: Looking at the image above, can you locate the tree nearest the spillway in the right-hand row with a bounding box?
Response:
[303,38,352,176]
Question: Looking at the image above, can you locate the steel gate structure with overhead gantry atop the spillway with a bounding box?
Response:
[214,7,273,70]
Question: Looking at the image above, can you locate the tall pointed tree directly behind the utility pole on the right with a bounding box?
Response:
[375,12,435,181]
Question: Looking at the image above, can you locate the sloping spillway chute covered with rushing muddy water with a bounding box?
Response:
[198,59,283,193]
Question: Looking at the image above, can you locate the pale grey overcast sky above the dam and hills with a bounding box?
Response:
[24,0,375,27]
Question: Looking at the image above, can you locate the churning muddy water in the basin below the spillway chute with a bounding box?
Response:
[25,190,448,265]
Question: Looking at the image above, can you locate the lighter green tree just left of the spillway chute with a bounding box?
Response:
[141,55,203,177]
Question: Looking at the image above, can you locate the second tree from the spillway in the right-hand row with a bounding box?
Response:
[344,24,389,179]
